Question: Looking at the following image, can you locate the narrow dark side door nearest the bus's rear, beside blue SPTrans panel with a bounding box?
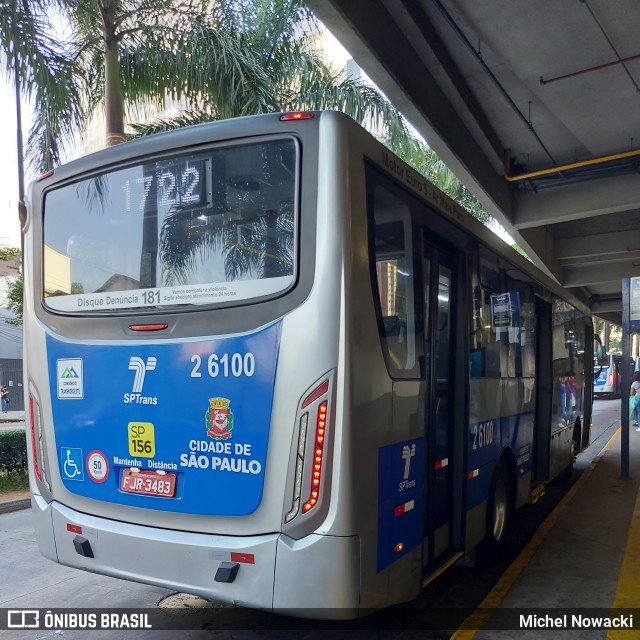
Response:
[422,236,460,567]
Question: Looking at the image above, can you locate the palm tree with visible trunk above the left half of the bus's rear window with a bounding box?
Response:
[69,0,280,144]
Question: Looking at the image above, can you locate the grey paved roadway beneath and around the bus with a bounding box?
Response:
[0,400,624,640]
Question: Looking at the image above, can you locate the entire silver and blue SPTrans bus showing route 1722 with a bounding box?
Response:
[24,112,593,618]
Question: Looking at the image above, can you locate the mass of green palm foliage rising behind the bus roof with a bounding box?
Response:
[0,0,504,245]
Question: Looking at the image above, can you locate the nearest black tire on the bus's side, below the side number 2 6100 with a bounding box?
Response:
[478,459,512,564]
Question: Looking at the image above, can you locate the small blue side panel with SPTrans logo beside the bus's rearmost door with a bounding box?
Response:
[377,438,424,572]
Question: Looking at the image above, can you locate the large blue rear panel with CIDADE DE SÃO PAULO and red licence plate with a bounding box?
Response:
[47,323,281,516]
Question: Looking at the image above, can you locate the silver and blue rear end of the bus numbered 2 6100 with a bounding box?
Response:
[24,116,359,617]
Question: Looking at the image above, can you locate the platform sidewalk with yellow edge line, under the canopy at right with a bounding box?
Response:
[460,420,640,640]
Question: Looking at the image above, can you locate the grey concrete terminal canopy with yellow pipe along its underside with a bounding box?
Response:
[307,0,640,323]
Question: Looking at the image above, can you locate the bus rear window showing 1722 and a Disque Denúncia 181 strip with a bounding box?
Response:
[43,138,299,313]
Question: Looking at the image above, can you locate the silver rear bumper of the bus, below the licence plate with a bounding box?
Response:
[32,495,360,618]
